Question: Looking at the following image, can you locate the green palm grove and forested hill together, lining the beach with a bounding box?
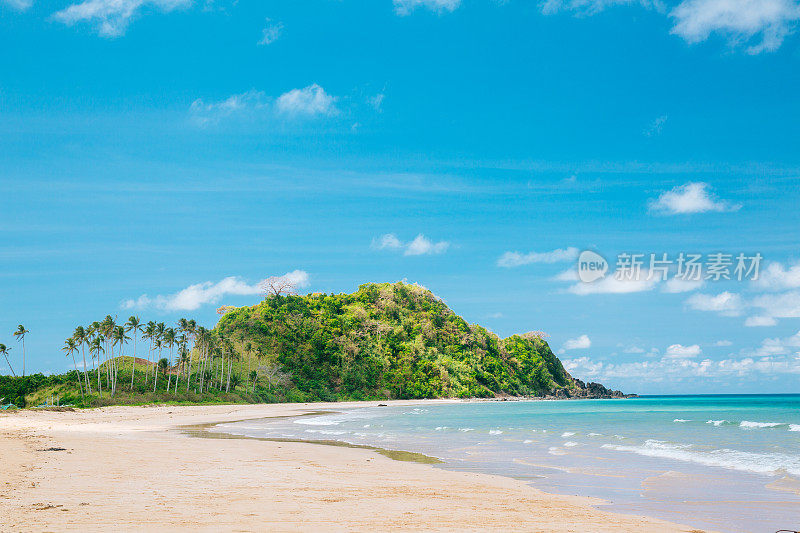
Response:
[0,283,584,407]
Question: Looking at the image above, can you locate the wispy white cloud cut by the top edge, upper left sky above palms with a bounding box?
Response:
[52,0,193,37]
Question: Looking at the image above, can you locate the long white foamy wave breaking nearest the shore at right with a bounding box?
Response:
[603,439,800,476]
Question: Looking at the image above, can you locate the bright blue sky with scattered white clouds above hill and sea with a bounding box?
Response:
[0,0,800,393]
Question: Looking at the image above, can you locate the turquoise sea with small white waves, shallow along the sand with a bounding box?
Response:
[212,395,800,532]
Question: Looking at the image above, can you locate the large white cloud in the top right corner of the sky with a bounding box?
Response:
[669,0,800,54]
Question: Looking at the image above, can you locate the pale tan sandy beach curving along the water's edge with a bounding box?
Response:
[0,402,693,532]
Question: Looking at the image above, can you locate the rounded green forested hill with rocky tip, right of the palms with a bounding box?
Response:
[215,283,618,400]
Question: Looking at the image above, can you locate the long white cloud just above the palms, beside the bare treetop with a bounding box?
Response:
[122,270,309,311]
